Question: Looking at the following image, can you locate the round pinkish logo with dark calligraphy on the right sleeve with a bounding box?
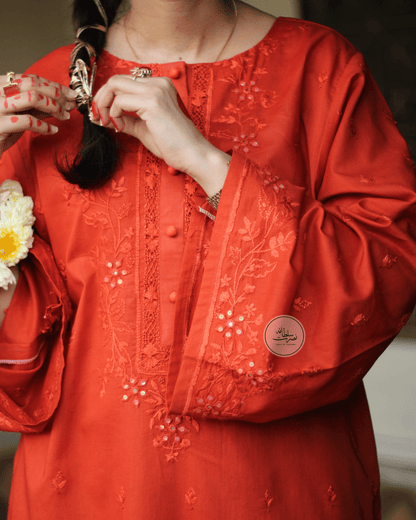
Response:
[264,316,305,357]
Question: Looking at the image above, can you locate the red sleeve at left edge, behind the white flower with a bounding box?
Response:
[0,143,71,432]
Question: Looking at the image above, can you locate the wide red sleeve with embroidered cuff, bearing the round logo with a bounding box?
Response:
[169,49,416,422]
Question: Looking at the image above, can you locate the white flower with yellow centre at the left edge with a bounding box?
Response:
[0,180,36,289]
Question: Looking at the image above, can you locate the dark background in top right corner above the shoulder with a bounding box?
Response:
[301,0,416,161]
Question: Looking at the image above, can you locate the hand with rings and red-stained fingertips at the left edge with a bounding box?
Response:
[0,74,76,157]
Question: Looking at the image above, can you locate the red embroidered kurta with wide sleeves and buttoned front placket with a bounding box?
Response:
[0,18,416,520]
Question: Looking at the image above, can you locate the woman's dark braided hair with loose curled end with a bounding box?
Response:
[55,0,123,189]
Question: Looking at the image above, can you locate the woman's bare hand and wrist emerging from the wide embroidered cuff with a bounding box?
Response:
[91,75,230,196]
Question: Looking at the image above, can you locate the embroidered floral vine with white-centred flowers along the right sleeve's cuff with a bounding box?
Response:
[191,169,297,419]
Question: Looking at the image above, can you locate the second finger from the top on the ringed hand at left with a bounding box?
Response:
[0,90,72,121]
